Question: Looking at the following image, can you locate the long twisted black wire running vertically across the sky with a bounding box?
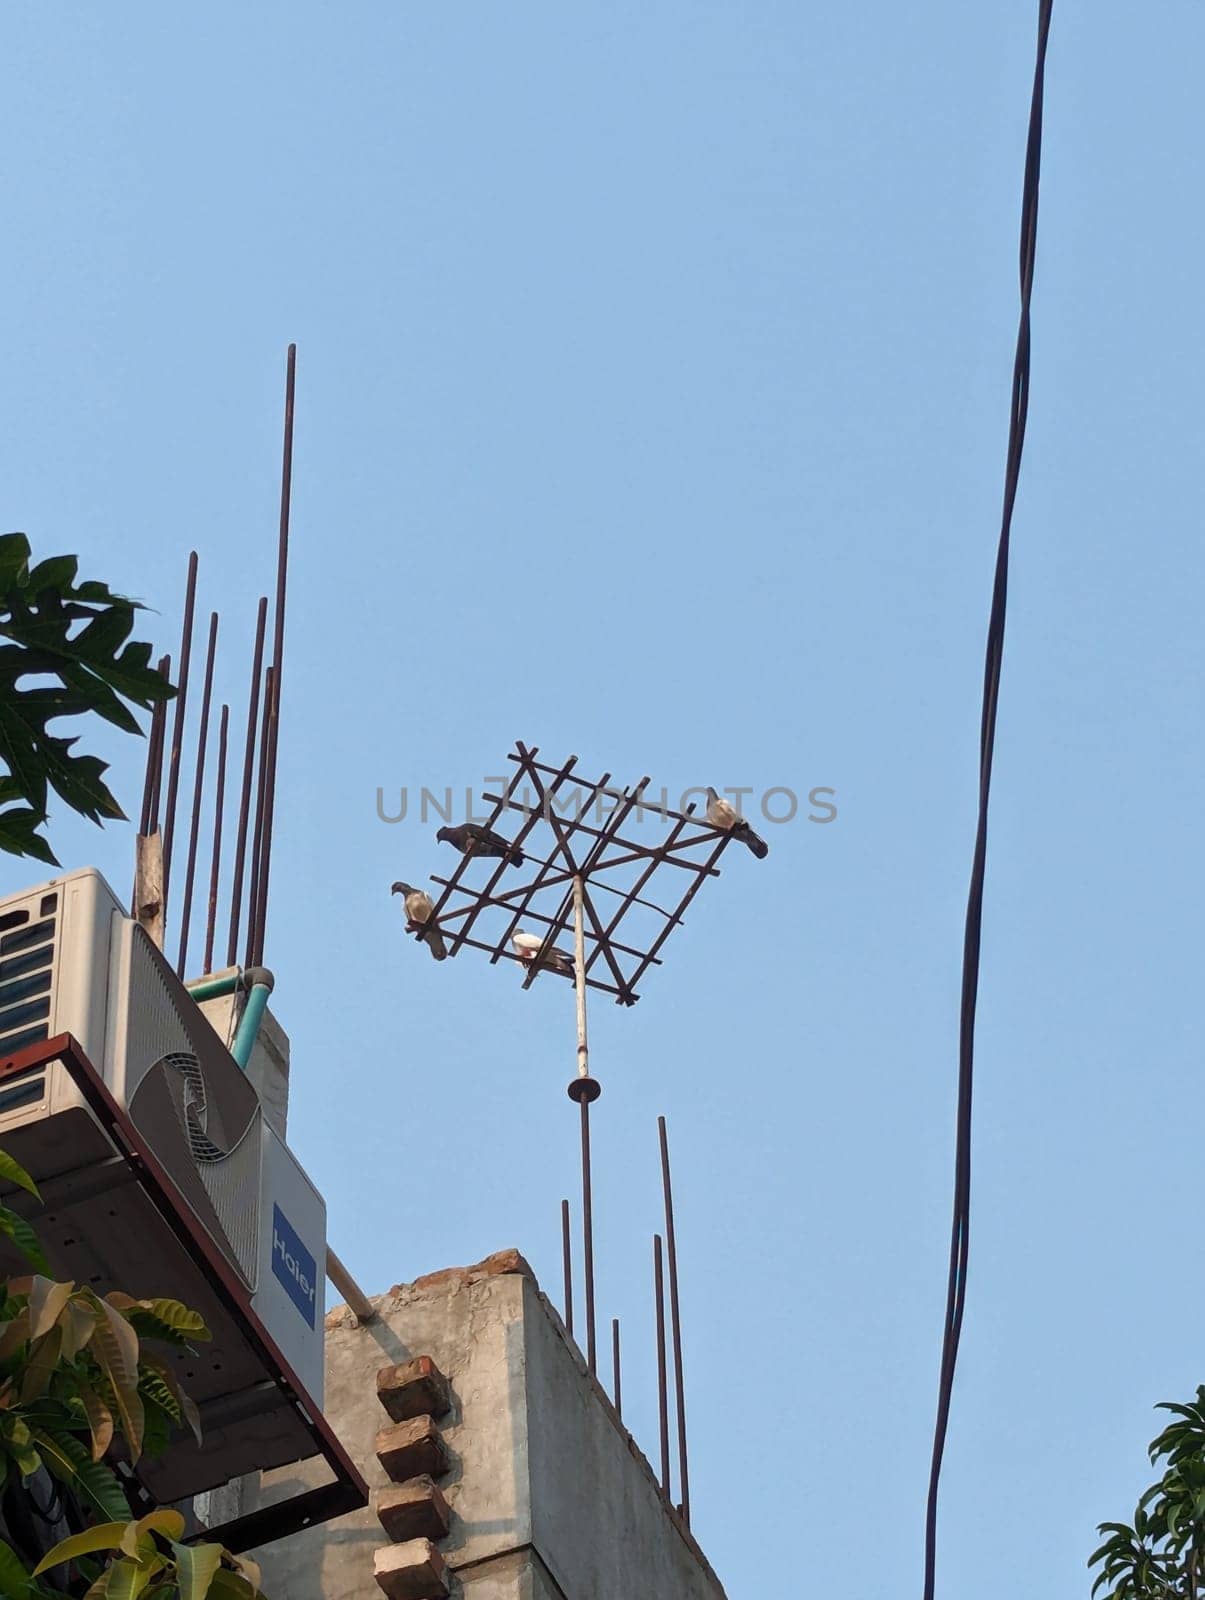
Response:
[923,0,1053,1600]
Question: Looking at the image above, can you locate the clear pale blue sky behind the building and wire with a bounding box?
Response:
[0,0,1205,1600]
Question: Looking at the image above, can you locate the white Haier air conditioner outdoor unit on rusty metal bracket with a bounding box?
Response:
[0,869,326,1498]
